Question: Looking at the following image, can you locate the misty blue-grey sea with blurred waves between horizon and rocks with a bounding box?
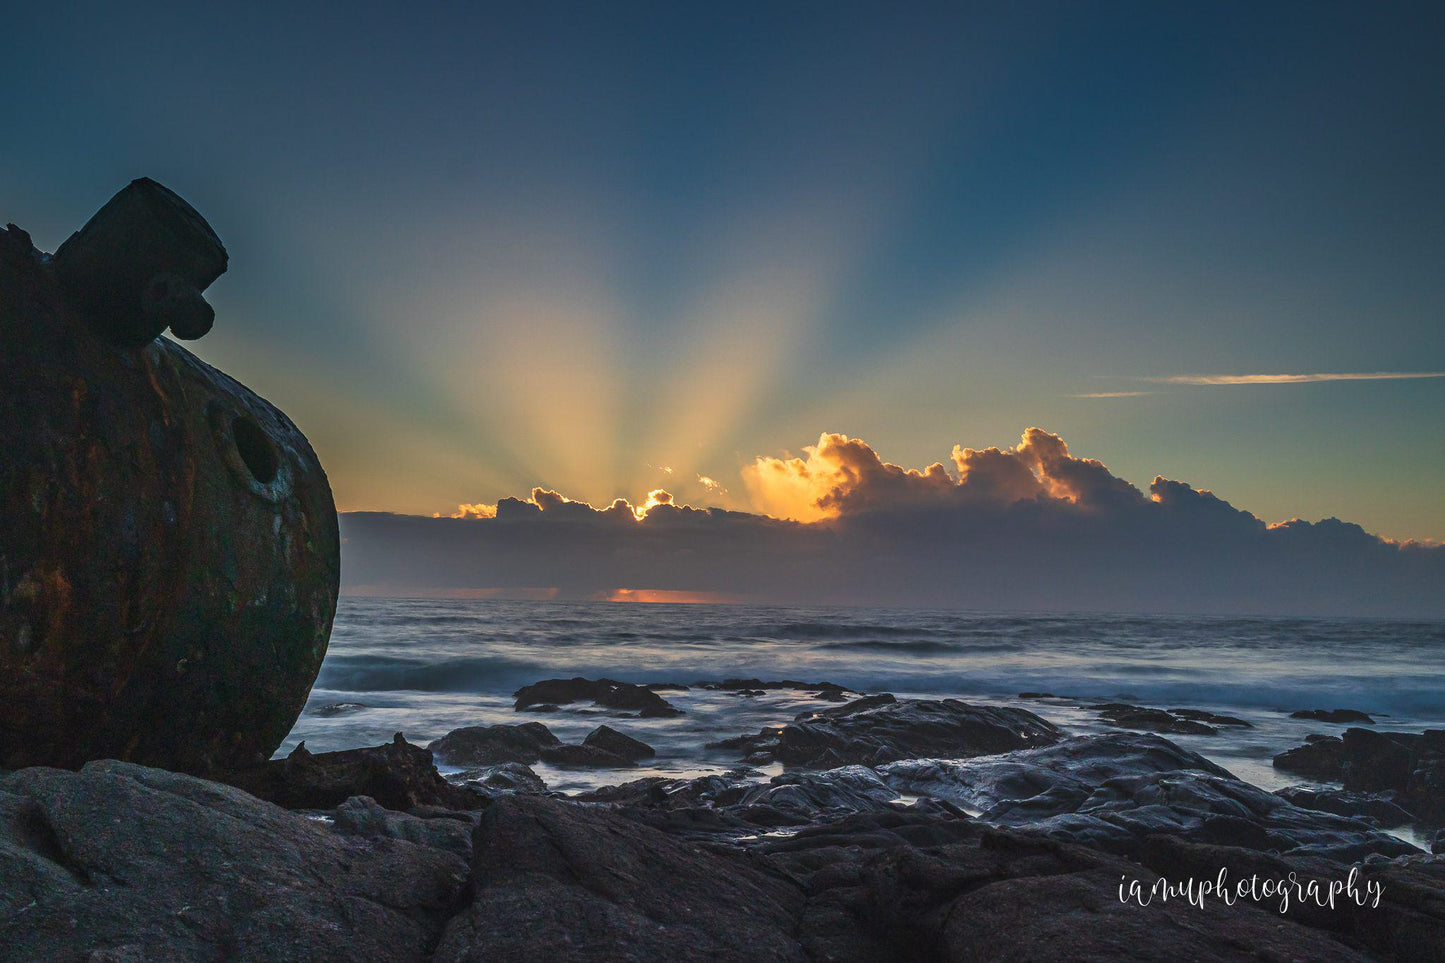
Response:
[277,596,1445,815]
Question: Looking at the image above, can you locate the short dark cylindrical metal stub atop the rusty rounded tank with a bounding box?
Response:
[52,178,227,347]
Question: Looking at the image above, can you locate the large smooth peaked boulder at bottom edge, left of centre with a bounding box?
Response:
[434,797,808,963]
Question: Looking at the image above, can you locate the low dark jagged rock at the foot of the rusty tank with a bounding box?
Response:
[217,733,486,813]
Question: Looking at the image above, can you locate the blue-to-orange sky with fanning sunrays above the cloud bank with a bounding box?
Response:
[0,3,1445,555]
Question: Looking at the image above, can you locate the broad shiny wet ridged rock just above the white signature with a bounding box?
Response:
[879,733,1418,860]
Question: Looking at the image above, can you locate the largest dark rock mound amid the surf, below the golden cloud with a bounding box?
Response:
[714,698,1061,769]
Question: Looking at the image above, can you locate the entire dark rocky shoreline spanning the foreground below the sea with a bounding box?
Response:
[0,680,1445,960]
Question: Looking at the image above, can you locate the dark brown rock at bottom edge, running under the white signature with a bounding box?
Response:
[750,813,1366,963]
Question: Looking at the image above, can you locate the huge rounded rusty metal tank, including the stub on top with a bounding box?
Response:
[0,185,340,772]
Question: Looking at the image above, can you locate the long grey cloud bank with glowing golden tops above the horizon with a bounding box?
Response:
[341,428,1445,617]
